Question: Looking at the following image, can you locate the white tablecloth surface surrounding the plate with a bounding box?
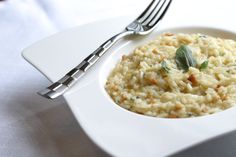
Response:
[0,0,236,157]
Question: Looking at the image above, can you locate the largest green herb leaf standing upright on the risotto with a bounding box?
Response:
[175,45,197,72]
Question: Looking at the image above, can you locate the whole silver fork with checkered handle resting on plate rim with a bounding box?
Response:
[38,0,172,99]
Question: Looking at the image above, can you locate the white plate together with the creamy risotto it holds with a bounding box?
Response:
[23,17,236,157]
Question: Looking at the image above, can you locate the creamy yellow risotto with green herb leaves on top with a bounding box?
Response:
[105,33,236,118]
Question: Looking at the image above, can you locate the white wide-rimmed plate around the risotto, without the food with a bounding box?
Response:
[23,16,236,157]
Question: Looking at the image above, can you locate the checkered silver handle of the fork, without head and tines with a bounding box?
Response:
[38,30,133,99]
